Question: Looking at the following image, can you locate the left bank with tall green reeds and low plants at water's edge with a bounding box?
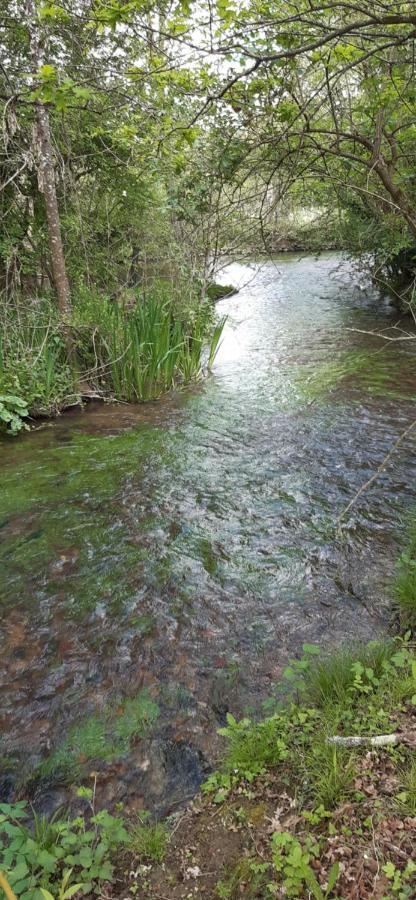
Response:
[0,284,228,436]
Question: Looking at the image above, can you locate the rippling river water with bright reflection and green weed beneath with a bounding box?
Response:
[0,254,416,811]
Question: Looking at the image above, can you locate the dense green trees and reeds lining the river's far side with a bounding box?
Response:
[0,0,416,434]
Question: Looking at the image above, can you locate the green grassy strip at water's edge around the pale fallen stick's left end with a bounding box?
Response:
[205,638,416,808]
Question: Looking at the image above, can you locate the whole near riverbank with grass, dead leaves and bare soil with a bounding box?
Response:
[0,634,416,900]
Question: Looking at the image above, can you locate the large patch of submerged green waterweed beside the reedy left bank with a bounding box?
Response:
[0,426,174,616]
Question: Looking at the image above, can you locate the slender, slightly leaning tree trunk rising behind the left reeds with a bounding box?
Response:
[26,0,74,359]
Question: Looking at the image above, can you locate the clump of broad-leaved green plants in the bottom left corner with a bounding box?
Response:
[0,788,168,900]
